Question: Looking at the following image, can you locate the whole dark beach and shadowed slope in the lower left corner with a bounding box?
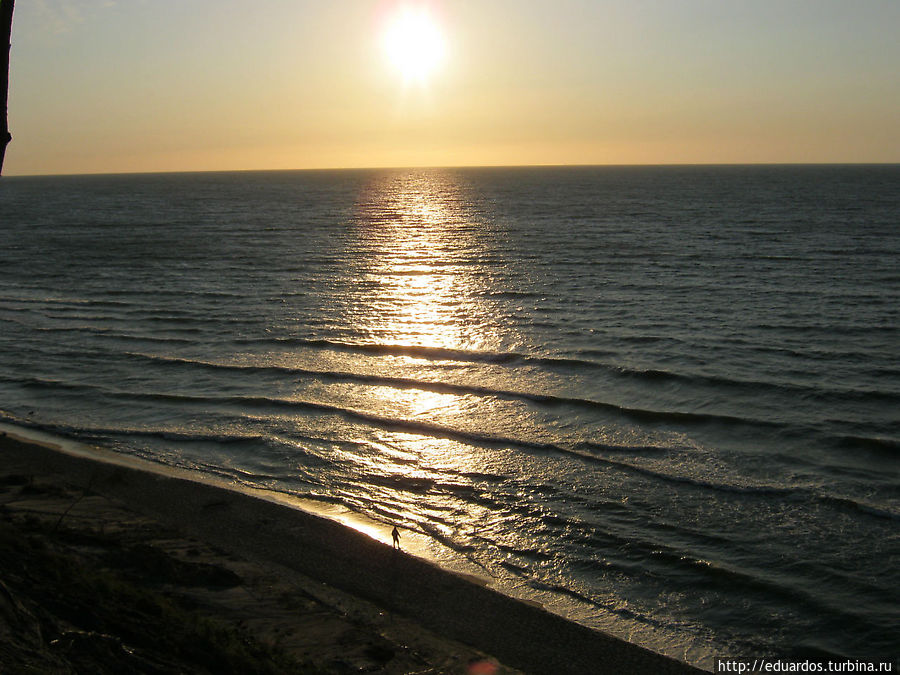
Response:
[0,433,700,673]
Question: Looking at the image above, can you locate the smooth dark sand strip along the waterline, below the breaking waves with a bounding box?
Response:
[0,436,702,673]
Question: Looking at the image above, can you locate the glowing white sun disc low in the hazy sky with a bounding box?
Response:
[383,5,445,84]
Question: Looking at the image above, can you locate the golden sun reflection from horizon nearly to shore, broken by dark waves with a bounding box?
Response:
[330,171,520,543]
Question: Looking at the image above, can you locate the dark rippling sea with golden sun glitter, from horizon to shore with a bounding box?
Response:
[0,165,900,668]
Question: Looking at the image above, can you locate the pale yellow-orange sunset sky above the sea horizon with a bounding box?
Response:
[4,0,900,175]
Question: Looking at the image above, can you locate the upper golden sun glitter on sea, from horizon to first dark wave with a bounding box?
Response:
[348,172,495,350]
